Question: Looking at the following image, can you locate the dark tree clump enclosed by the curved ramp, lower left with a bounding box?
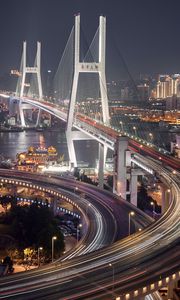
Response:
[1,204,64,257]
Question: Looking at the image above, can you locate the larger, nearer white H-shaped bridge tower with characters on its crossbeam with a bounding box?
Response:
[66,14,109,185]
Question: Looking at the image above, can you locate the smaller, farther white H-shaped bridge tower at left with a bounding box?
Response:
[16,41,43,127]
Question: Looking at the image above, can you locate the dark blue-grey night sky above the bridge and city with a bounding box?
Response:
[0,0,180,76]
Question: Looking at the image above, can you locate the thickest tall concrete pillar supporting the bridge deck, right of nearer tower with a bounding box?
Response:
[113,136,128,199]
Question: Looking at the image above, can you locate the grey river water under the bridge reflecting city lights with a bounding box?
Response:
[0,130,98,167]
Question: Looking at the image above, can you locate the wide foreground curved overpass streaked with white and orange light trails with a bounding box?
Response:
[0,165,180,300]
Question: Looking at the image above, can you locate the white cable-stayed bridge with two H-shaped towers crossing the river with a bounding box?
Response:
[0,15,180,299]
